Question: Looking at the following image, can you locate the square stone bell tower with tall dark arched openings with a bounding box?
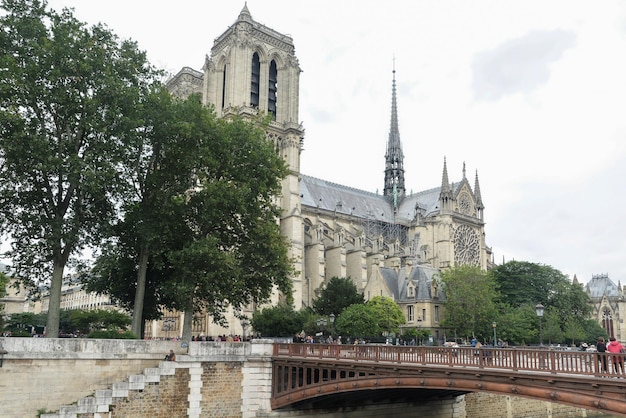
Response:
[202,5,304,306]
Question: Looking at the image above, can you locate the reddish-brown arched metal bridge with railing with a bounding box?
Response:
[271,343,626,417]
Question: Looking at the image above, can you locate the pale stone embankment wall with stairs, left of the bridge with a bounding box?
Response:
[0,338,272,418]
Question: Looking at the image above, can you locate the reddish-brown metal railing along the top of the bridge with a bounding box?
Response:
[274,343,626,377]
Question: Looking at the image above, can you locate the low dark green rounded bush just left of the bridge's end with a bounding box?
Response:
[250,303,311,337]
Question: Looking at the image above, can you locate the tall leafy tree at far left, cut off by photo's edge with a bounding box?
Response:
[0,0,156,337]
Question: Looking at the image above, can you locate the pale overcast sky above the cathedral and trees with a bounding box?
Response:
[49,0,626,284]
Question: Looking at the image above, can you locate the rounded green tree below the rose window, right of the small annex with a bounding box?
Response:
[441,265,499,339]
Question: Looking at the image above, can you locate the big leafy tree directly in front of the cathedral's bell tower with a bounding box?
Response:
[165,111,293,337]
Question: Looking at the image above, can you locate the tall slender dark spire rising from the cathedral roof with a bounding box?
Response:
[383,62,406,208]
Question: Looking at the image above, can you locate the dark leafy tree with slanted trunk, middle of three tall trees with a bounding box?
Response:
[88,86,207,335]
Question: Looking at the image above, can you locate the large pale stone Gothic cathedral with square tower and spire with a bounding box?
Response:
[162,6,493,340]
